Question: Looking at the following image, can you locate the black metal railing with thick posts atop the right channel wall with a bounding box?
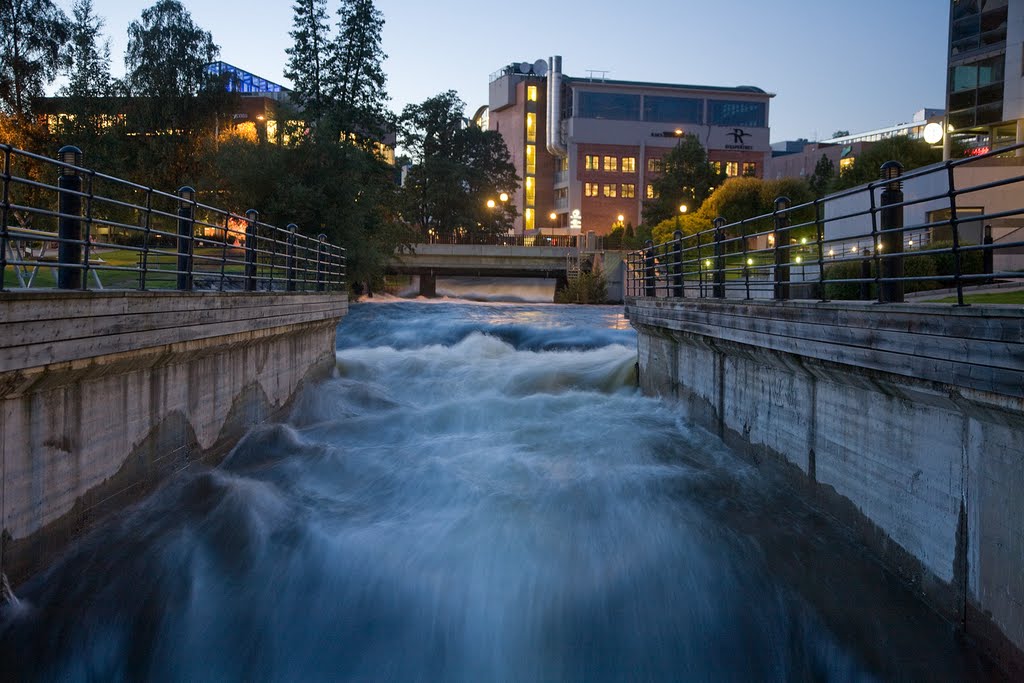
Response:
[626,144,1024,305]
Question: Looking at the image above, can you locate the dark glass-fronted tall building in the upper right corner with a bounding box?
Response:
[945,0,1024,157]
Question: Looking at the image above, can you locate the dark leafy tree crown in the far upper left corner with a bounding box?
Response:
[0,0,70,121]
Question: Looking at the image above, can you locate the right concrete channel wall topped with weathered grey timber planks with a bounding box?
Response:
[626,298,1024,672]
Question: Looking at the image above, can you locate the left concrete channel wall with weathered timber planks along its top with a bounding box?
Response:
[0,292,348,586]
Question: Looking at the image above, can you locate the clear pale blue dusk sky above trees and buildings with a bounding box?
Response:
[75,0,949,141]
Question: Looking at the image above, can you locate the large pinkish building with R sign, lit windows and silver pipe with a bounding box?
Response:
[478,56,772,234]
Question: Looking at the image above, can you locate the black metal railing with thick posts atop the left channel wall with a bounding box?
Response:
[0,144,345,292]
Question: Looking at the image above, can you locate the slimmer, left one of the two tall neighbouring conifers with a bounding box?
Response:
[285,0,330,122]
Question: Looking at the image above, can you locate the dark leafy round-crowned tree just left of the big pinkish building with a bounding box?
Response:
[401,90,519,240]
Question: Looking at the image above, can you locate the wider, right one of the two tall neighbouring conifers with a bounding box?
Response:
[327,0,387,139]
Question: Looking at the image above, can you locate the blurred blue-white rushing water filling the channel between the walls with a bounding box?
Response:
[0,303,995,681]
